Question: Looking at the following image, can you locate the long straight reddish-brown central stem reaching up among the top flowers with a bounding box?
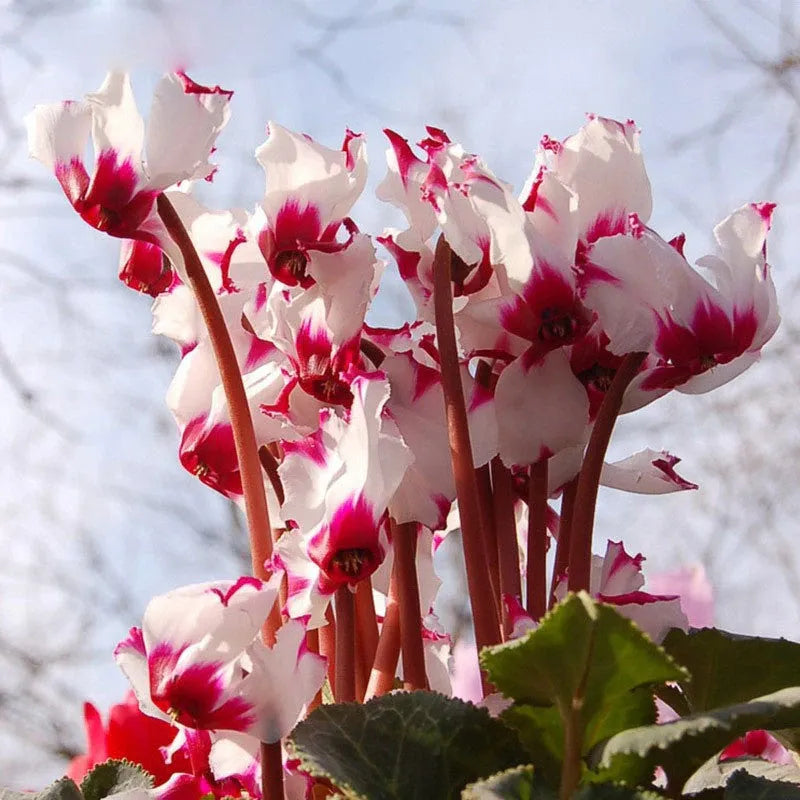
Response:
[433,236,501,668]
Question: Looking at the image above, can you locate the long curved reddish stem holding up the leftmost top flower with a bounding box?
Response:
[157,193,275,644]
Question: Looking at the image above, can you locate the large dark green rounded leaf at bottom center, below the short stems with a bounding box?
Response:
[291,692,527,800]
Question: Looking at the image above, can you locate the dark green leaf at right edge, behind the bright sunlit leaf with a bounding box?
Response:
[664,628,800,712]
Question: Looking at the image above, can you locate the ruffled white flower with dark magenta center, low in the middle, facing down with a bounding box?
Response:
[274,374,412,627]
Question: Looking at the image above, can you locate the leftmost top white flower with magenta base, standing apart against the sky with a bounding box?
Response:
[26,72,232,268]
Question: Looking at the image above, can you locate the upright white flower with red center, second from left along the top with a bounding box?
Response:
[256,122,367,289]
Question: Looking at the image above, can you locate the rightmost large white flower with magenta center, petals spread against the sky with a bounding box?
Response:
[586,204,779,393]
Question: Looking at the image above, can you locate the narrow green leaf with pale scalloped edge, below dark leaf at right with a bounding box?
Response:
[597,687,800,791]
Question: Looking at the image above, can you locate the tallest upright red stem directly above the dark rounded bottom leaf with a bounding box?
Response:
[392,520,428,690]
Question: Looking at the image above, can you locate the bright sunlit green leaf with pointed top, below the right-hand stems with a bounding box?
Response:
[481,592,688,781]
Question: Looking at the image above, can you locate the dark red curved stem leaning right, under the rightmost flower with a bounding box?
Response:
[569,353,647,592]
